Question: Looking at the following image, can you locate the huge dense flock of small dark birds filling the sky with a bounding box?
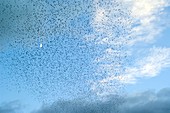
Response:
[0,0,131,100]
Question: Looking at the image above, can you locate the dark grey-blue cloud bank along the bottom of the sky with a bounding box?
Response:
[0,88,170,113]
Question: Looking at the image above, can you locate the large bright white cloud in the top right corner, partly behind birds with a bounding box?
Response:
[85,0,170,46]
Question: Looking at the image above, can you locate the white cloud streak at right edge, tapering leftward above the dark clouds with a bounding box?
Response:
[99,48,170,85]
